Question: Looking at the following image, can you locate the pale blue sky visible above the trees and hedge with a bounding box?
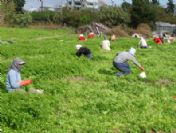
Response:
[24,0,176,9]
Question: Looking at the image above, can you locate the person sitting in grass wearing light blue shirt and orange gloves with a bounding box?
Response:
[6,58,43,93]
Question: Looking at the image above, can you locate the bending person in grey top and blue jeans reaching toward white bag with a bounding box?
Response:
[113,48,144,76]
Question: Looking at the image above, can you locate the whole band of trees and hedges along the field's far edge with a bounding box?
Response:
[0,0,176,28]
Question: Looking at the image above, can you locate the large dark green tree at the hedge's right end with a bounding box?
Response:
[131,0,156,27]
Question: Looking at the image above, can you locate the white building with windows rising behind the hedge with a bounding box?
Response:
[66,0,98,9]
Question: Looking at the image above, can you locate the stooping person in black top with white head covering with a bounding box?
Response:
[76,44,92,59]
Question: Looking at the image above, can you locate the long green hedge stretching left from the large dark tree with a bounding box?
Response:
[28,6,130,27]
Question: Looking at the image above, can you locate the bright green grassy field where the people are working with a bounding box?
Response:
[0,28,176,133]
